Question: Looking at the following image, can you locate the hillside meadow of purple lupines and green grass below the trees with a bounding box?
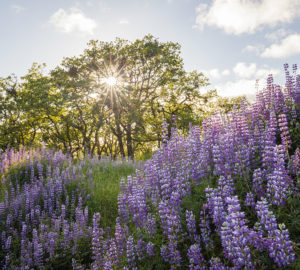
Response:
[0,66,300,270]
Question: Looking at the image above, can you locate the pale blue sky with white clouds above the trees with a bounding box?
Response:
[0,0,300,96]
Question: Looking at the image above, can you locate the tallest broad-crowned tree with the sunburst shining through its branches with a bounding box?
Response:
[51,35,208,157]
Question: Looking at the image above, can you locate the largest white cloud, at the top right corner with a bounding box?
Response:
[196,0,300,35]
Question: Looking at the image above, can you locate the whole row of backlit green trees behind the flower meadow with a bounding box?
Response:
[0,35,241,158]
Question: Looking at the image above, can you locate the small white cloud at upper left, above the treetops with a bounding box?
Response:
[49,8,97,35]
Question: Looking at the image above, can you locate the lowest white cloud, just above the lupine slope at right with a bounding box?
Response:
[215,79,256,97]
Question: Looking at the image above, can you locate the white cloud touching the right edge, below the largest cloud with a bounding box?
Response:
[261,34,300,58]
